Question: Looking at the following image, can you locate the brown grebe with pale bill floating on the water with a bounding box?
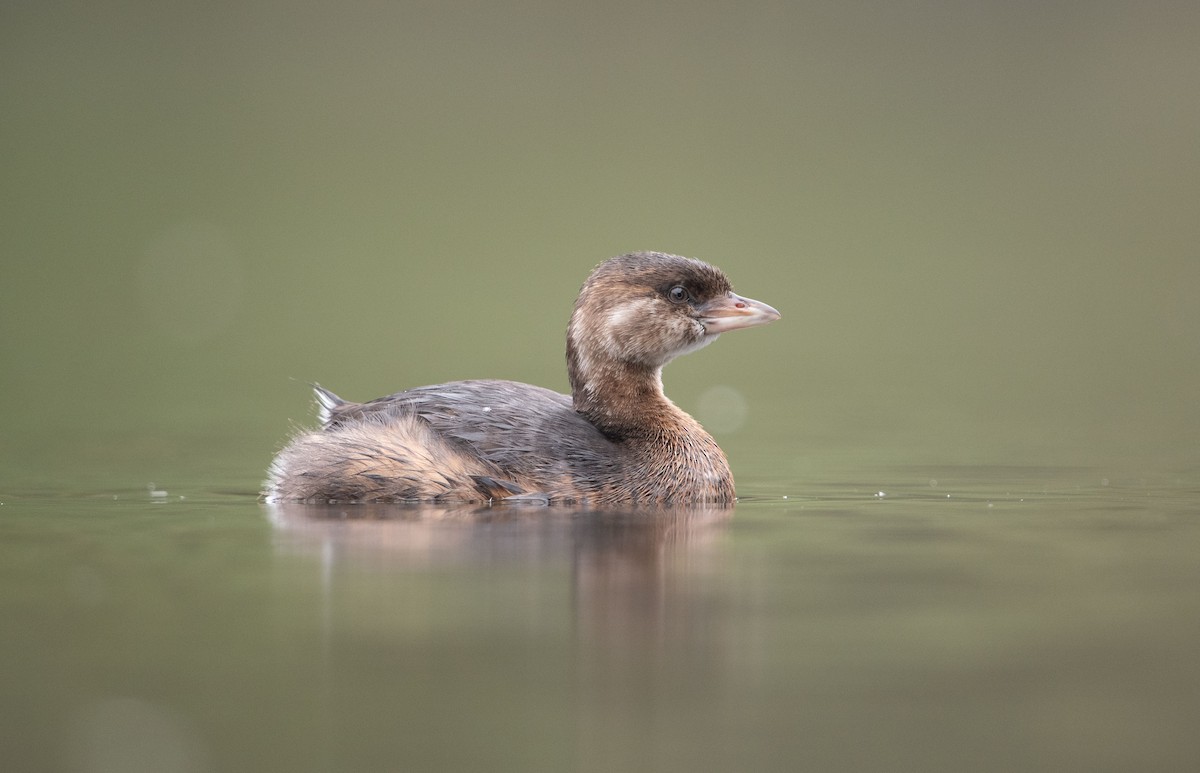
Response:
[264,252,779,504]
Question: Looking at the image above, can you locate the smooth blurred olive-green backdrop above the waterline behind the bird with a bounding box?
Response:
[0,0,1200,491]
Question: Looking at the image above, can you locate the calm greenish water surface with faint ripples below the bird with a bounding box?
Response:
[0,456,1200,772]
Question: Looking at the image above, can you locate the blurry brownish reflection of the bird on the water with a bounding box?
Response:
[264,504,738,771]
